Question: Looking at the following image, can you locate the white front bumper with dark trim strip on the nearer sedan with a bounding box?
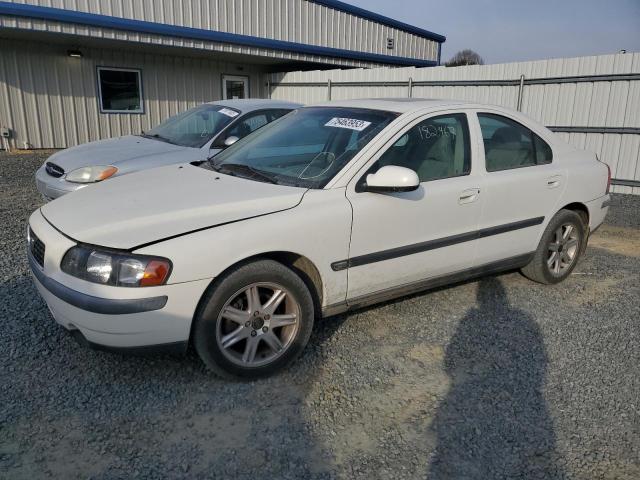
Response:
[28,211,211,349]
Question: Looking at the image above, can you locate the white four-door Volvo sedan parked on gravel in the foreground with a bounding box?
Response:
[28,99,609,377]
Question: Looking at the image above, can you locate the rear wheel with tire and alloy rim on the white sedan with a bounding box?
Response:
[521,210,586,285]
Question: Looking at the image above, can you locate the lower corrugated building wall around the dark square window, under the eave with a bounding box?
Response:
[0,39,264,148]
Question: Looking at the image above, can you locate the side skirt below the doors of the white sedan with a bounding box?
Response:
[322,252,535,317]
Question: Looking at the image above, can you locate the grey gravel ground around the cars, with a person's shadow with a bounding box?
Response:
[0,154,640,479]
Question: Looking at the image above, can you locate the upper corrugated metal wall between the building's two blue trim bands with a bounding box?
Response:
[5,0,438,64]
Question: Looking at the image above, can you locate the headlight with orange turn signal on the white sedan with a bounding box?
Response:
[60,245,171,287]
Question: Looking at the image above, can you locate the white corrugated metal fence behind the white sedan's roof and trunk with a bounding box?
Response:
[268,53,640,194]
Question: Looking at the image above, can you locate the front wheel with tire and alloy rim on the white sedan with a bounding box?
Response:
[192,260,314,379]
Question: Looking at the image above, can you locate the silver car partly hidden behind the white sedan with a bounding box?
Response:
[36,99,301,200]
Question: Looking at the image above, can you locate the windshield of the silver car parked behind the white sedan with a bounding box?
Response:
[142,105,240,148]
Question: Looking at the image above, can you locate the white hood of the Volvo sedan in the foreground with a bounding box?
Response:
[41,163,306,250]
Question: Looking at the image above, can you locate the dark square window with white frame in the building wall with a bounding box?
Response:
[98,67,144,113]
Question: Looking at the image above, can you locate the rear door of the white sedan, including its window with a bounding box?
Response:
[474,111,566,265]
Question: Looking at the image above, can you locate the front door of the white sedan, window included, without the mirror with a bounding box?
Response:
[347,112,482,304]
